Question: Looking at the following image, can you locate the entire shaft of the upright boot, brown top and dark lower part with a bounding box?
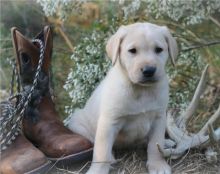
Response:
[11,26,53,123]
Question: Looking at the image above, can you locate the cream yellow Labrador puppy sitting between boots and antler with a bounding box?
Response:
[68,23,178,174]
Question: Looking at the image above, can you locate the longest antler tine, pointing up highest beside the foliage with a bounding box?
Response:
[177,65,209,129]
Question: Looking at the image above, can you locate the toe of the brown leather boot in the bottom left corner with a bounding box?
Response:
[0,135,50,174]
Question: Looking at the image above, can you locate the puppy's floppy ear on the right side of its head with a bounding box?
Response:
[162,26,178,66]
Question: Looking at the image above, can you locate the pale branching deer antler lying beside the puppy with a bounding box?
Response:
[157,65,220,159]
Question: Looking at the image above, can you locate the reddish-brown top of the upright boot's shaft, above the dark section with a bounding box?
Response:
[11,26,53,85]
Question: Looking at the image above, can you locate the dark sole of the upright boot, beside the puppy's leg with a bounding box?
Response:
[48,148,93,167]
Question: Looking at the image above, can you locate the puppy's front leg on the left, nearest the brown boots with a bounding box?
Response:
[86,117,121,174]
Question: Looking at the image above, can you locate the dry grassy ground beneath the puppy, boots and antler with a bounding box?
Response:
[47,149,220,174]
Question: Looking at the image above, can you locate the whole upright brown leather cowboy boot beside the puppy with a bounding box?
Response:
[12,26,92,162]
